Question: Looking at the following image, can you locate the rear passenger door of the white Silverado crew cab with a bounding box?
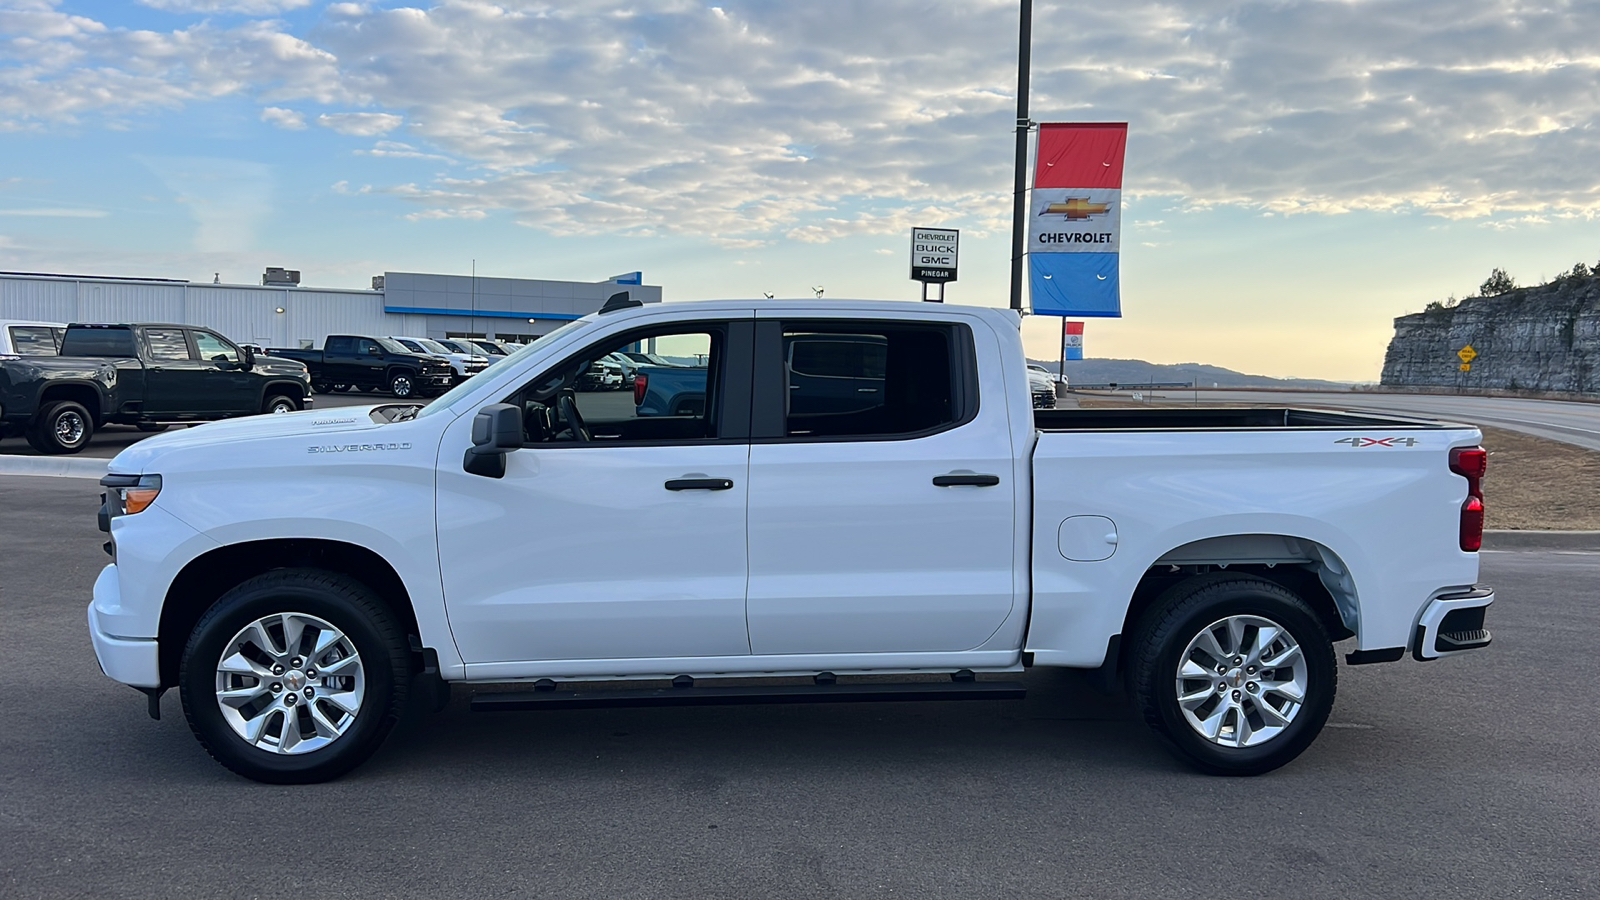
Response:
[747,322,1024,655]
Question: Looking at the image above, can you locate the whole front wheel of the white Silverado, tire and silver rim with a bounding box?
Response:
[178,569,411,785]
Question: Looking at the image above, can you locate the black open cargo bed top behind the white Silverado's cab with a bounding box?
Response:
[1034,407,1459,431]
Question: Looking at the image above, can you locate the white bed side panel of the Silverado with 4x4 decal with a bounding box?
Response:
[1027,429,1480,666]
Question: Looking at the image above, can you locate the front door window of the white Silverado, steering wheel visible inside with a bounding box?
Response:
[506,325,725,445]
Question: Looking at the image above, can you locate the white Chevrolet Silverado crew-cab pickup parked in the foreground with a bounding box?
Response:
[88,298,1494,783]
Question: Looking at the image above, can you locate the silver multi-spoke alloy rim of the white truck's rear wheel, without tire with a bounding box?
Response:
[1178,615,1306,748]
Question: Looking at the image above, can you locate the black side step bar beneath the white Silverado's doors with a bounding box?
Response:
[472,681,1027,713]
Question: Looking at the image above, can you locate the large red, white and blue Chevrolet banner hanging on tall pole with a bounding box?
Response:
[1027,122,1128,317]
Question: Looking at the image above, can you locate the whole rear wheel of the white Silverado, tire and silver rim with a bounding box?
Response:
[1130,572,1338,775]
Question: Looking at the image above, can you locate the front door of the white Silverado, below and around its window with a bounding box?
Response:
[438,312,752,662]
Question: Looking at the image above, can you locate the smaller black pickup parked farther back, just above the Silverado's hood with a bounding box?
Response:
[267,335,454,397]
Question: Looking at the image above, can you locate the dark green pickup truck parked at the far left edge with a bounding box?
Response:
[0,325,310,453]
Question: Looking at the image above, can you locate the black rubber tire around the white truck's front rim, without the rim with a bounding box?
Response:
[178,569,411,785]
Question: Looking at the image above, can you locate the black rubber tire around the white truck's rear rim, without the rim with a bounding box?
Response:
[1147,583,1338,775]
